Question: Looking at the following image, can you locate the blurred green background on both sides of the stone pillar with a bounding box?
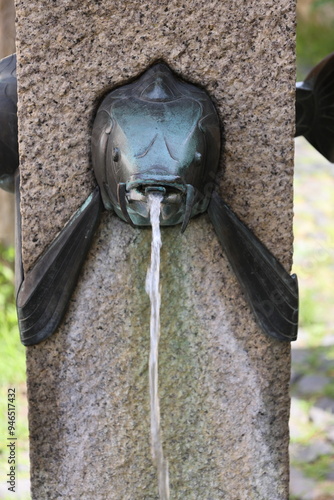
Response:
[0,0,334,500]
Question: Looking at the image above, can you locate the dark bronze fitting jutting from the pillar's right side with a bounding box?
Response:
[295,53,334,163]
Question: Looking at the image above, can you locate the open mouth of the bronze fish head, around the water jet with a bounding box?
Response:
[117,175,196,232]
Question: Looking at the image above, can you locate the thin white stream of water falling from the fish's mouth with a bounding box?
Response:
[146,193,169,500]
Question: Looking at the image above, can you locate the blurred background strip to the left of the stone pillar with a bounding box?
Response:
[0,0,30,500]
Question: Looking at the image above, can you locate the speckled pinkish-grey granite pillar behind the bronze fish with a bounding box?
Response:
[16,0,295,500]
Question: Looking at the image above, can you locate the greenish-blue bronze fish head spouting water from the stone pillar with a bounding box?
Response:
[92,63,220,230]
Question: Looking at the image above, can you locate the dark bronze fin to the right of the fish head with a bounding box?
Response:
[208,193,298,341]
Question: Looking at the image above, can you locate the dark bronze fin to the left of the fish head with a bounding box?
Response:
[17,188,101,346]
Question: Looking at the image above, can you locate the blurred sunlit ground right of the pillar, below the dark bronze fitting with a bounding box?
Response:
[290,138,334,500]
